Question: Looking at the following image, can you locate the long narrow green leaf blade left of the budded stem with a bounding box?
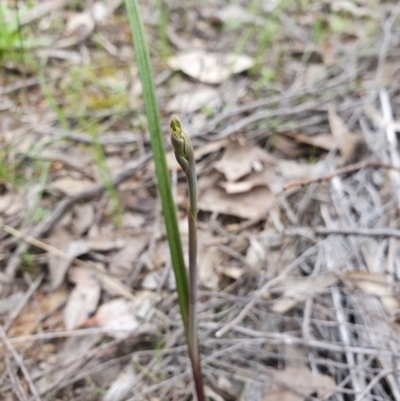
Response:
[125,0,189,337]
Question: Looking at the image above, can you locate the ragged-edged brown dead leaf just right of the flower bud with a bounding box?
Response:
[214,140,275,181]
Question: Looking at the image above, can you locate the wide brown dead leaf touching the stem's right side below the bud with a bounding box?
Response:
[199,187,275,219]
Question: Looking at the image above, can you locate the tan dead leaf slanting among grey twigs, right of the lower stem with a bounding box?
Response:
[271,273,338,313]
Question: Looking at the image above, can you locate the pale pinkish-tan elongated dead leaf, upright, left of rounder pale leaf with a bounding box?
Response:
[63,268,101,330]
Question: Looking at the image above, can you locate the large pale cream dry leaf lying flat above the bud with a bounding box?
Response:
[168,50,254,84]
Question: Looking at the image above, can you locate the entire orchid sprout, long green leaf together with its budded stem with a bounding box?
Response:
[125,0,205,401]
